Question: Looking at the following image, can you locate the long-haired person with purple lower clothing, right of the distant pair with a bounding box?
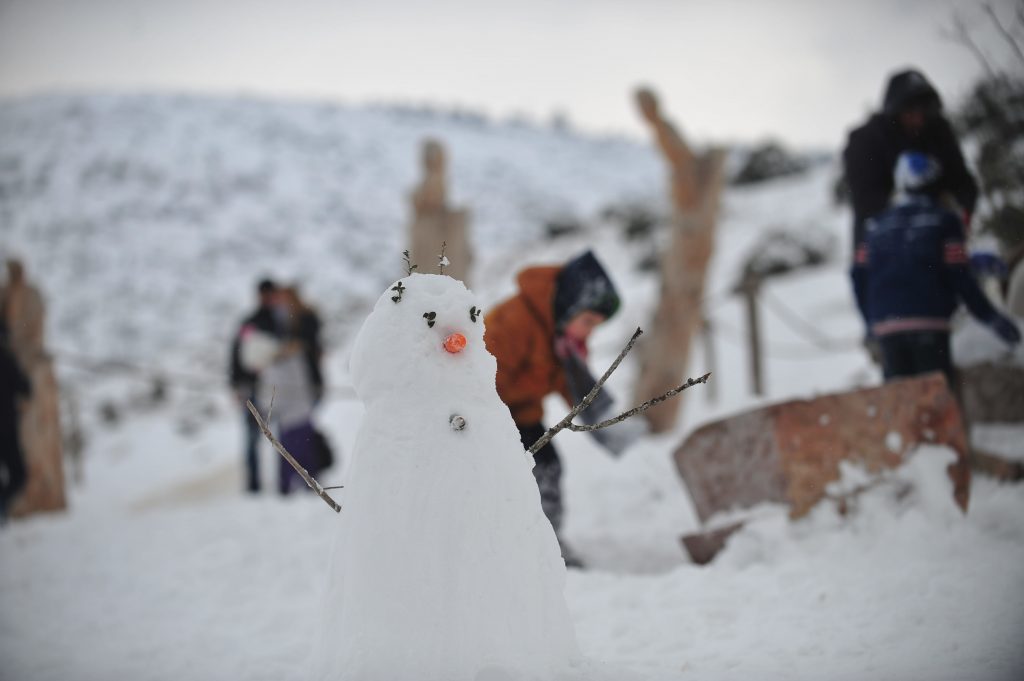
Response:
[253,287,323,495]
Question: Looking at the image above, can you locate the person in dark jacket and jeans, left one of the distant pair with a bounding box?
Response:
[228,279,281,493]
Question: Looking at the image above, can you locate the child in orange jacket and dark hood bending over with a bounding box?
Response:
[484,251,643,567]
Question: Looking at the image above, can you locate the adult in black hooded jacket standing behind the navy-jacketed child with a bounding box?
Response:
[843,69,978,249]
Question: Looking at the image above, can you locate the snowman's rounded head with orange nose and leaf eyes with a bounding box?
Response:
[349,273,496,401]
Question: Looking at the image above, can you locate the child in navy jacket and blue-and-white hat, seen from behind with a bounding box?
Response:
[852,152,1021,388]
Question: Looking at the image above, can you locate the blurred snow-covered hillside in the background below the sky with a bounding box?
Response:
[0,95,662,374]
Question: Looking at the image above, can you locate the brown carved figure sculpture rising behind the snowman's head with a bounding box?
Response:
[409,139,473,286]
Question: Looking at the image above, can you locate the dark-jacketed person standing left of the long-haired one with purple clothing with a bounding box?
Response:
[228,280,282,493]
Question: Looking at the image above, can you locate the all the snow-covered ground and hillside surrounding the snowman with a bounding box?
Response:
[6,97,1024,681]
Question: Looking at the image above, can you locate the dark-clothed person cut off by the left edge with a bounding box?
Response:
[0,323,32,522]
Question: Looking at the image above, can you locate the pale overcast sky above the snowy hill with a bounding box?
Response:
[0,0,1021,147]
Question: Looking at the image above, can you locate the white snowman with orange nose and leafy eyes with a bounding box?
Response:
[314,273,579,681]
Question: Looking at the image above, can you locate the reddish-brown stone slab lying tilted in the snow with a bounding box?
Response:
[675,374,971,521]
